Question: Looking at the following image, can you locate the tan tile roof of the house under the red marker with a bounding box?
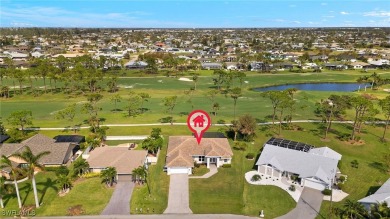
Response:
[166,136,233,167]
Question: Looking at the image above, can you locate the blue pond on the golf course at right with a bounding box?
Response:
[253,83,371,92]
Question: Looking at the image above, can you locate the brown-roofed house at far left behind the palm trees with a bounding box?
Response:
[0,134,84,173]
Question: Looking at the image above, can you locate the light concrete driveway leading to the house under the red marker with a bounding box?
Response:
[164,173,192,214]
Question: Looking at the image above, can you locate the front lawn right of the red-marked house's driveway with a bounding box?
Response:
[190,145,295,218]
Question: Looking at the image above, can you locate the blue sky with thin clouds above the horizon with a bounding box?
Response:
[0,0,390,28]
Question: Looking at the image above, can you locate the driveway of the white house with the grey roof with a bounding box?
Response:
[276,188,324,219]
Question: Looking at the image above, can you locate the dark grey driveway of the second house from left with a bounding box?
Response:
[101,181,134,215]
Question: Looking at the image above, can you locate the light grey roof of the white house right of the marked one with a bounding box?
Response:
[256,144,341,184]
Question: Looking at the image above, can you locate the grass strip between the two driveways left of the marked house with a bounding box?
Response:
[130,139,169,214]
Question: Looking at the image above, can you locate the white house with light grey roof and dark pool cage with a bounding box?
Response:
[256,138,341,190]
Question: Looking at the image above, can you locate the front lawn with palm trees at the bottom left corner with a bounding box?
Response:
[1,172,114,216]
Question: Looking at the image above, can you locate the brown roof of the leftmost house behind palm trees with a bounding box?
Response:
[0,134,76,165]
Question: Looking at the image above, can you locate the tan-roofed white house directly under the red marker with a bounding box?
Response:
[166,136,233,175]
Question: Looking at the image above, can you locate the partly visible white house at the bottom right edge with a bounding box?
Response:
[358,178,390,211]
